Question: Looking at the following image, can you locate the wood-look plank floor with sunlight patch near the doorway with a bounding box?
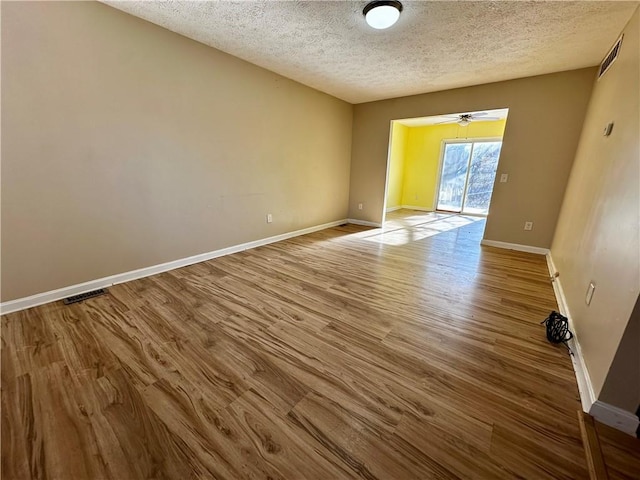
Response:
[1,211,588,480]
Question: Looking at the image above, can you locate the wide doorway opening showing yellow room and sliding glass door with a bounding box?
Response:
[382,108,508,232]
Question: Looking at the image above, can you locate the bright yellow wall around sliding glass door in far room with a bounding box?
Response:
[400,120,506,210]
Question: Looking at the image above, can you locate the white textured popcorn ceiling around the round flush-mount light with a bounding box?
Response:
[104,0,638,103]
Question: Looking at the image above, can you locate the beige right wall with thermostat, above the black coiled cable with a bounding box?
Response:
[552,10,640,404]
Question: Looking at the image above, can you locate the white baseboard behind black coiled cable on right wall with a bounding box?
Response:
[547,252,604,414]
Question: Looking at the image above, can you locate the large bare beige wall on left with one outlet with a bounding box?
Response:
[1,2,352,301]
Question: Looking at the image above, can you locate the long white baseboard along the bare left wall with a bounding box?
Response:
[0,219,347,315]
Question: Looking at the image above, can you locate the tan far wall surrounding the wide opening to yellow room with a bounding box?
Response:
[349,68,595,248]
